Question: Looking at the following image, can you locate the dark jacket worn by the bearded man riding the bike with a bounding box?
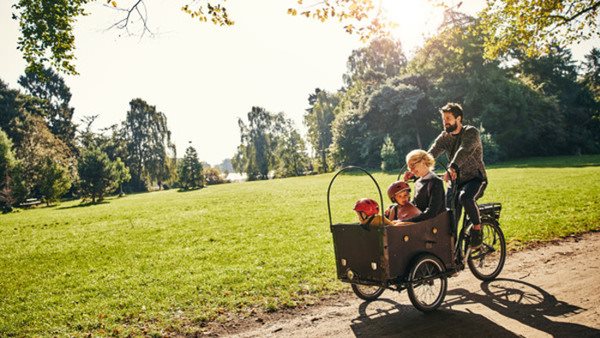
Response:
[428,125,487,183]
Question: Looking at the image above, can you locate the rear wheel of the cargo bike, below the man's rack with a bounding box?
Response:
[467,219,506,281]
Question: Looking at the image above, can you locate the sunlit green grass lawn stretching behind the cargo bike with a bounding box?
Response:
[0,156,600,336]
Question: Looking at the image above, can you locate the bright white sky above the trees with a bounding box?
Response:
[0,0,592,165]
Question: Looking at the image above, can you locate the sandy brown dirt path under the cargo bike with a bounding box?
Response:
[220,232,600,337]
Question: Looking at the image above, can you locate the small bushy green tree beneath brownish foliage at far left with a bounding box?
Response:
[39,157,71,206]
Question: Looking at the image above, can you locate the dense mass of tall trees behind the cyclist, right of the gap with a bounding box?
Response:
[304,11,600,172]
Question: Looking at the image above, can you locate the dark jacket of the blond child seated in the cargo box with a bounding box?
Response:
[404,174,446,222]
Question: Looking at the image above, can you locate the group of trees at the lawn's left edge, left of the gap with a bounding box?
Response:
[0,68,230,211]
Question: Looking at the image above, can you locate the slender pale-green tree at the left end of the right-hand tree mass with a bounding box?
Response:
[304,88,339,173]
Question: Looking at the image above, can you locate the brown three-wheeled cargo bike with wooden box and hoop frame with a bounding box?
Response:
[327,166,506,312]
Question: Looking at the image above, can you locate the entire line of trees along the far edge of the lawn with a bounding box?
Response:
[0,7,600,210]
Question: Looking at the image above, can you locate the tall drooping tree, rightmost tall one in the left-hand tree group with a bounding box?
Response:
[124,99,176,191]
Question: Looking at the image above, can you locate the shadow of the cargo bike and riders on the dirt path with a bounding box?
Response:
[351,279,600,337]
